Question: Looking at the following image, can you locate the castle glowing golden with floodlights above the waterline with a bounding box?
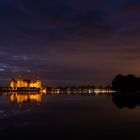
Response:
[10,76,41,89]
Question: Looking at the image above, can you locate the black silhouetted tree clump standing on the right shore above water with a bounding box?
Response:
[112,74,140,92]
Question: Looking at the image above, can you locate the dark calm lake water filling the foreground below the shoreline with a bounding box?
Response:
[0,94,140,140]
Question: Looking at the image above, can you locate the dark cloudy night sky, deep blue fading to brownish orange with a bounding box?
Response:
[0,0,140,86]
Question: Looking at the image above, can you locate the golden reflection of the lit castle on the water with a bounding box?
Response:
[10,92,42,104]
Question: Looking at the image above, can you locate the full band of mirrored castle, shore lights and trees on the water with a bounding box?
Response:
[1,91,140,109]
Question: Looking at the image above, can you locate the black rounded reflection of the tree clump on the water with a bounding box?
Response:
[112,93,140,109]
